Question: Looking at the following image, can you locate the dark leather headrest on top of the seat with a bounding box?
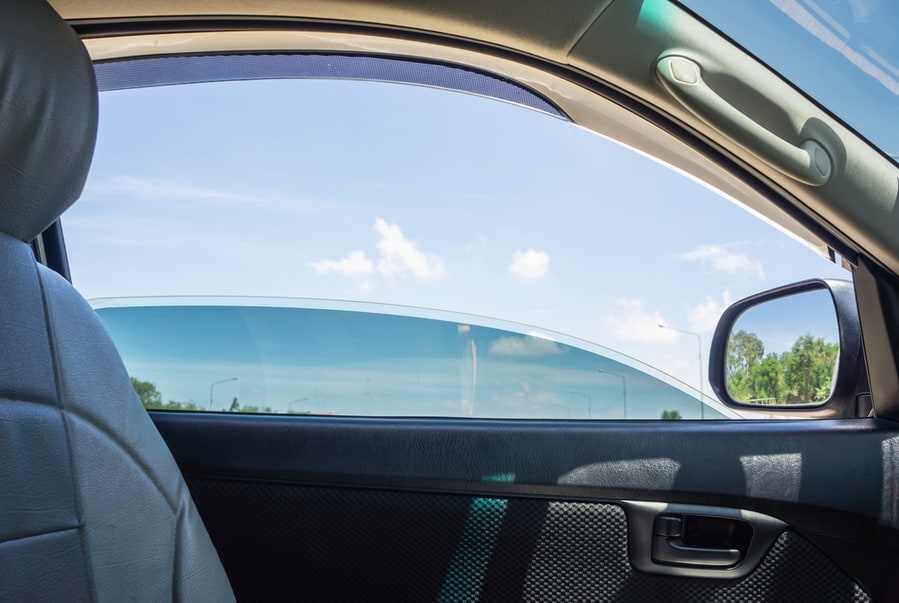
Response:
[0,0,97,241]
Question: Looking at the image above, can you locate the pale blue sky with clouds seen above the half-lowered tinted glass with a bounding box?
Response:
[63,74,850,416]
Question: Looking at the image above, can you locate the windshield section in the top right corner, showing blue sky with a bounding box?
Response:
[682,0,899,161]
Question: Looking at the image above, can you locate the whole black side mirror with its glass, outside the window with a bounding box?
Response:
[709,280,869,417]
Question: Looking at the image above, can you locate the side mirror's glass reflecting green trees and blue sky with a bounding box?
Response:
[725,289,840,406]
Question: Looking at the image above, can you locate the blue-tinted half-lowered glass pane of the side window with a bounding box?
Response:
[95,298,728,419]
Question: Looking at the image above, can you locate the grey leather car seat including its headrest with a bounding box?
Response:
[0,0,234,601]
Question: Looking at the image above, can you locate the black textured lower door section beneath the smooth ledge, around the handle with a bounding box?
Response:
[189,480,868,601]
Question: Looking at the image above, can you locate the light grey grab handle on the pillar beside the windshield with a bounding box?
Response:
[656,55,833,186]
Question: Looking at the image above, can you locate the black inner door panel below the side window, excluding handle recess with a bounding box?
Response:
[153,412,899,601]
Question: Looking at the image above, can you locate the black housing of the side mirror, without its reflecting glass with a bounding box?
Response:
[709,279,868,418]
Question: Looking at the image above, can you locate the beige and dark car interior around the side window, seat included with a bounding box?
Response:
[0,0,899,602]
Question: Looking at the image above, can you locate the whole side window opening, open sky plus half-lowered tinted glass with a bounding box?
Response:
[63,54,849,418]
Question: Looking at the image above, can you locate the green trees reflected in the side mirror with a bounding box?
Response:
[725,330,840,404]
